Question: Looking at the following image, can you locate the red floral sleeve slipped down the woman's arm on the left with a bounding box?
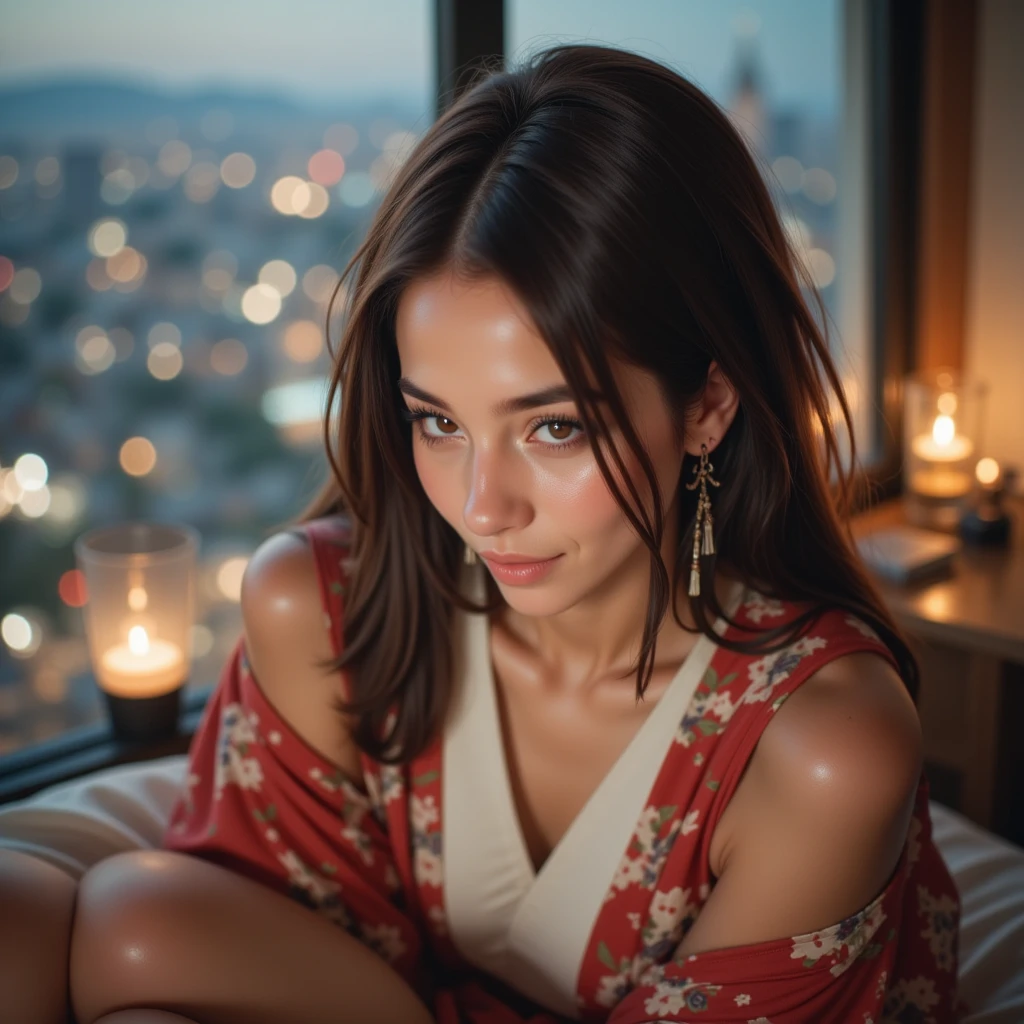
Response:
[163,520,423,988]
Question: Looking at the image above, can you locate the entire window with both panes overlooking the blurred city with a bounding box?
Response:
[0,0,922,770]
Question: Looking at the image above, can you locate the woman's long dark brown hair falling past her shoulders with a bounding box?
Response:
[288,45,918,763]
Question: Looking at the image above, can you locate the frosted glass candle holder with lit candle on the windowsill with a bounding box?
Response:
[75,521,199,739]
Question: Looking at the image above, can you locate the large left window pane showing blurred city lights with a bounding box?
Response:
[0,0,435,754]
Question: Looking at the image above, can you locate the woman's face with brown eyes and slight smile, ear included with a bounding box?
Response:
[396,272,683,614]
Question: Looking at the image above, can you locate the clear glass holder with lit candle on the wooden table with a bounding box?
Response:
[903,371,985,530]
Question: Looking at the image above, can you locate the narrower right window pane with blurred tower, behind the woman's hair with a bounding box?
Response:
[506,0,876,462]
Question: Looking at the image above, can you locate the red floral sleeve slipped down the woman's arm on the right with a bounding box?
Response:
[607,781,964,1024]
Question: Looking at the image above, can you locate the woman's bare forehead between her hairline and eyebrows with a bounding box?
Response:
[395,271,562,387]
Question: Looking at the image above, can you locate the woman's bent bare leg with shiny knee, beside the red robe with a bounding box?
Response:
[71,850,432,1024]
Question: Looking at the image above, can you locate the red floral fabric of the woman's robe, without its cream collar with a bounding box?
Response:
[159,519,959,1024]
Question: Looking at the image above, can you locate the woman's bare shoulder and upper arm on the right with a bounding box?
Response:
[684,652,923,953]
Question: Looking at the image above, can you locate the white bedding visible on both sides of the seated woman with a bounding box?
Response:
[0,754,1024,1024]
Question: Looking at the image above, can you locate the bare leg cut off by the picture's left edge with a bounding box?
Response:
[0,850,78,1024]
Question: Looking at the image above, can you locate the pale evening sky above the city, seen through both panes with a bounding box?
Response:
[0,0,840,109]
